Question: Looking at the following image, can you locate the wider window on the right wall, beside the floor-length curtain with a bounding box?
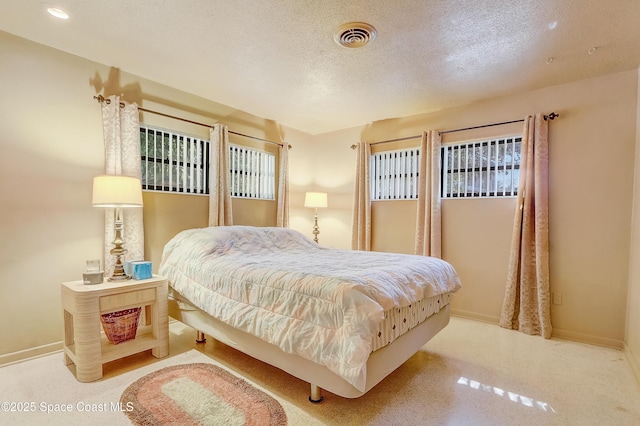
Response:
[441,137,522,198]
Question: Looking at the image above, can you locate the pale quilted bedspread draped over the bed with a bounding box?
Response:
[158,226,460,391]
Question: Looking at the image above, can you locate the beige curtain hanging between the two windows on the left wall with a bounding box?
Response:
[209,124,233,226]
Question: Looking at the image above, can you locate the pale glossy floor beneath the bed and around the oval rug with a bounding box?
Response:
[0,318,640,426]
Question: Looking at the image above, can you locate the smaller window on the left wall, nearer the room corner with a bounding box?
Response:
[229,145,276,200]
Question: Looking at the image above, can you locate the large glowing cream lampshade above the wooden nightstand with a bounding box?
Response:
[92,175,142,207]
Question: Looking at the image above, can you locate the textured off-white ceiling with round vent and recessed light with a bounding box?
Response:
[0,0,640,134]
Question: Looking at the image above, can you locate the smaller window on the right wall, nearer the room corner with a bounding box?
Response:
[369,148,420,200]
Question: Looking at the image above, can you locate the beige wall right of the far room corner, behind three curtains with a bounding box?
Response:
[314,70,638,347]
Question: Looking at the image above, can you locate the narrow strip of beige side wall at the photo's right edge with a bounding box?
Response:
[625,68,640,380]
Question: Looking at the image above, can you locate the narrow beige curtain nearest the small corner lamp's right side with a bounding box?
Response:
[351,142,371,250]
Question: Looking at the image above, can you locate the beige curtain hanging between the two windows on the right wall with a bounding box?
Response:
[415,130,442,257]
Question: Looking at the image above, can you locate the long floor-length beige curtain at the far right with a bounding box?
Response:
[500,114,551,339]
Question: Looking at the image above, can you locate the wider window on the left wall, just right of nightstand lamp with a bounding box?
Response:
[140,125,209,194]
